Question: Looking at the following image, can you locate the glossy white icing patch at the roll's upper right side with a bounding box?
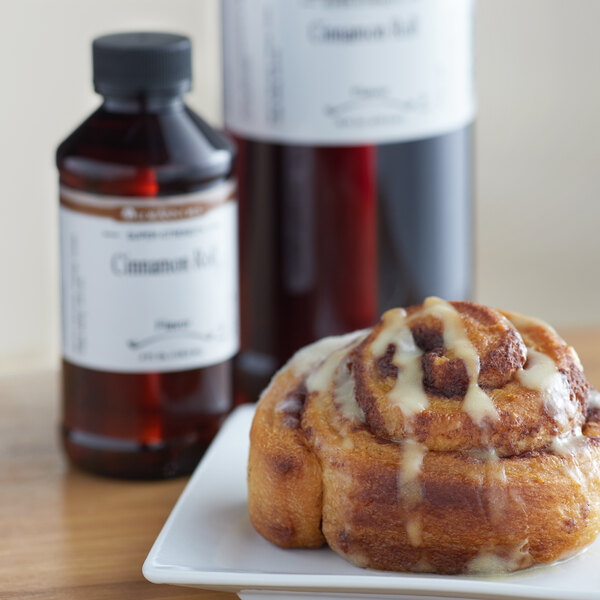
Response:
[517,348,577,430]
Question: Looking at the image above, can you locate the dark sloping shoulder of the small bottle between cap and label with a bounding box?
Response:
[56,104,234,195]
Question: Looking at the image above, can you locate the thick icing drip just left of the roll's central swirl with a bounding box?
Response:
[372,309,429,419]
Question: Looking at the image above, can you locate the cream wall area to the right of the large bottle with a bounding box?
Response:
[476,0,600,325]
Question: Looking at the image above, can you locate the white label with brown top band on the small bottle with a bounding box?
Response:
[60,181,239,373]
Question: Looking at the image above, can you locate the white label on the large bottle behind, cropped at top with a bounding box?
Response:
[223,0,475,145]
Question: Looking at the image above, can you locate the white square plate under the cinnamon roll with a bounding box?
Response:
[143,406,600,600]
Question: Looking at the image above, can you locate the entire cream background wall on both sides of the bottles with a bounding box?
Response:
[0,0,600,373]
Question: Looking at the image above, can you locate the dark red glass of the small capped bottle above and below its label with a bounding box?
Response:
[57,32,232,478]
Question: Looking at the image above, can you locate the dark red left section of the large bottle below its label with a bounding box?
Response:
[235,138,377,401]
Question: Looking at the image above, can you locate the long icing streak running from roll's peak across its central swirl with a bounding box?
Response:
[423,297,498,425]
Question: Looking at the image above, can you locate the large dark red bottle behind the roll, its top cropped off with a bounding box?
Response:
[223,0,474,399]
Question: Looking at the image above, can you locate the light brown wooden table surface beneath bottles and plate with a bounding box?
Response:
[0,328,600,600]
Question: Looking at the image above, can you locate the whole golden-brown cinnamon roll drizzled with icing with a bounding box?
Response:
[248,298,600,573]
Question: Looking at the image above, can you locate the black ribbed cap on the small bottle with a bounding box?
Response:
[92,32,192,95]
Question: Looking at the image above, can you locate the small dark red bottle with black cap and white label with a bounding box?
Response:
[57,33,238,478]
